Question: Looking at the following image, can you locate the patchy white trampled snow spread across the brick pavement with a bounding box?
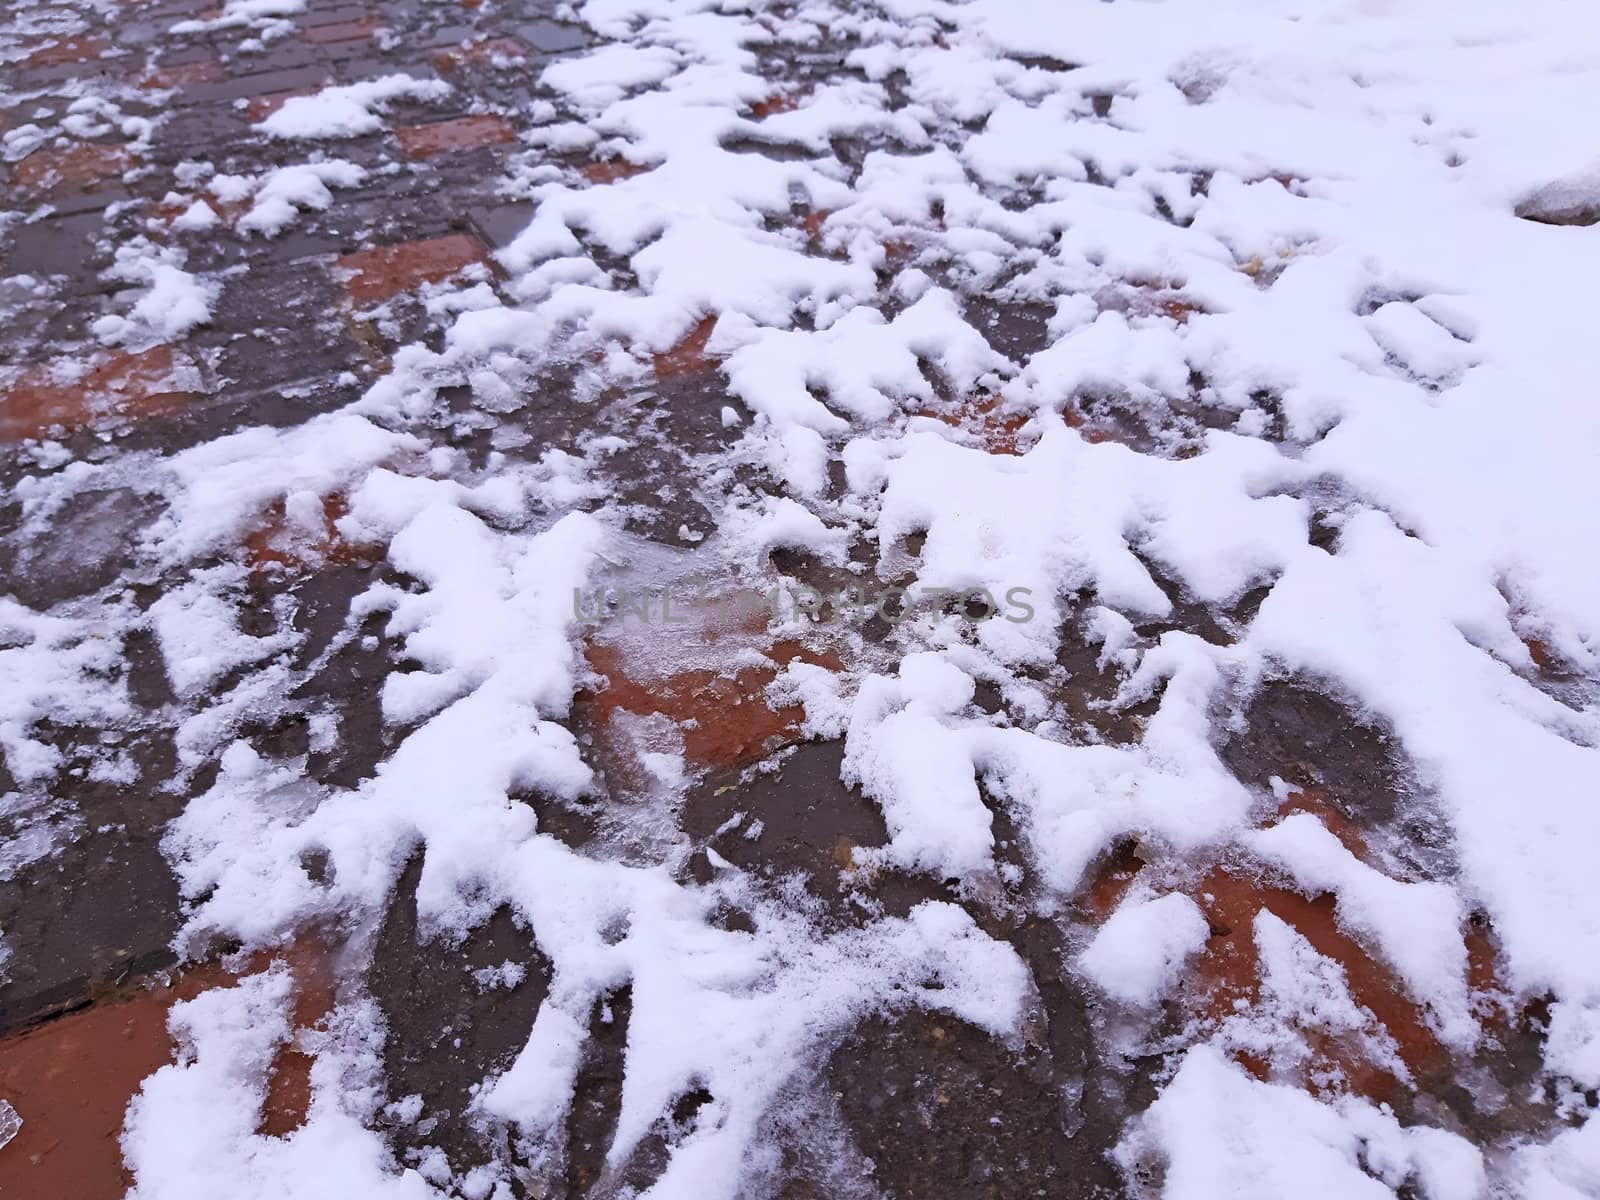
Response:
[0,0,1600,1200]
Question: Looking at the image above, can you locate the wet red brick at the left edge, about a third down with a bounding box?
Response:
[0,346,189,443]
